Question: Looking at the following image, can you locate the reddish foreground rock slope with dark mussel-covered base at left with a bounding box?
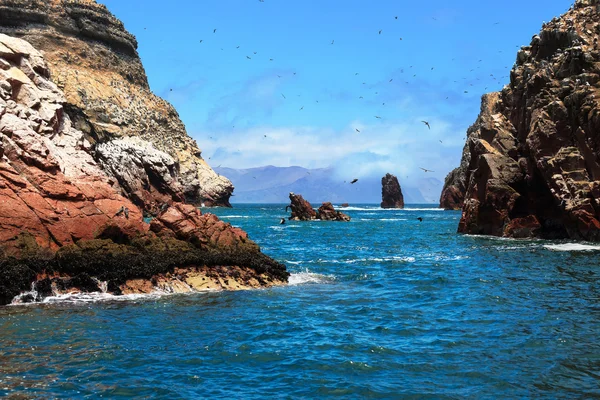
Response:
[0,34,287,304]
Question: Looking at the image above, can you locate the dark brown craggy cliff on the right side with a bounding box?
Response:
[441,0,600,240]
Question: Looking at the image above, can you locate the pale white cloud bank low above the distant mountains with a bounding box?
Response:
[193,116,464,183]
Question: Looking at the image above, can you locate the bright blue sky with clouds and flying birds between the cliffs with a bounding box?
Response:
[100,0,572,188]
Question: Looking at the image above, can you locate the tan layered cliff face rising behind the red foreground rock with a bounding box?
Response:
[0,0,233,214]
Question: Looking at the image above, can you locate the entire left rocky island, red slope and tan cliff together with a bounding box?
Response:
[0,0,288,304]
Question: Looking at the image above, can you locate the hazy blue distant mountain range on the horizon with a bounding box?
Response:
[214,165,443,204]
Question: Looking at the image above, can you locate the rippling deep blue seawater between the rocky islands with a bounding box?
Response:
[0,205,600,399]
